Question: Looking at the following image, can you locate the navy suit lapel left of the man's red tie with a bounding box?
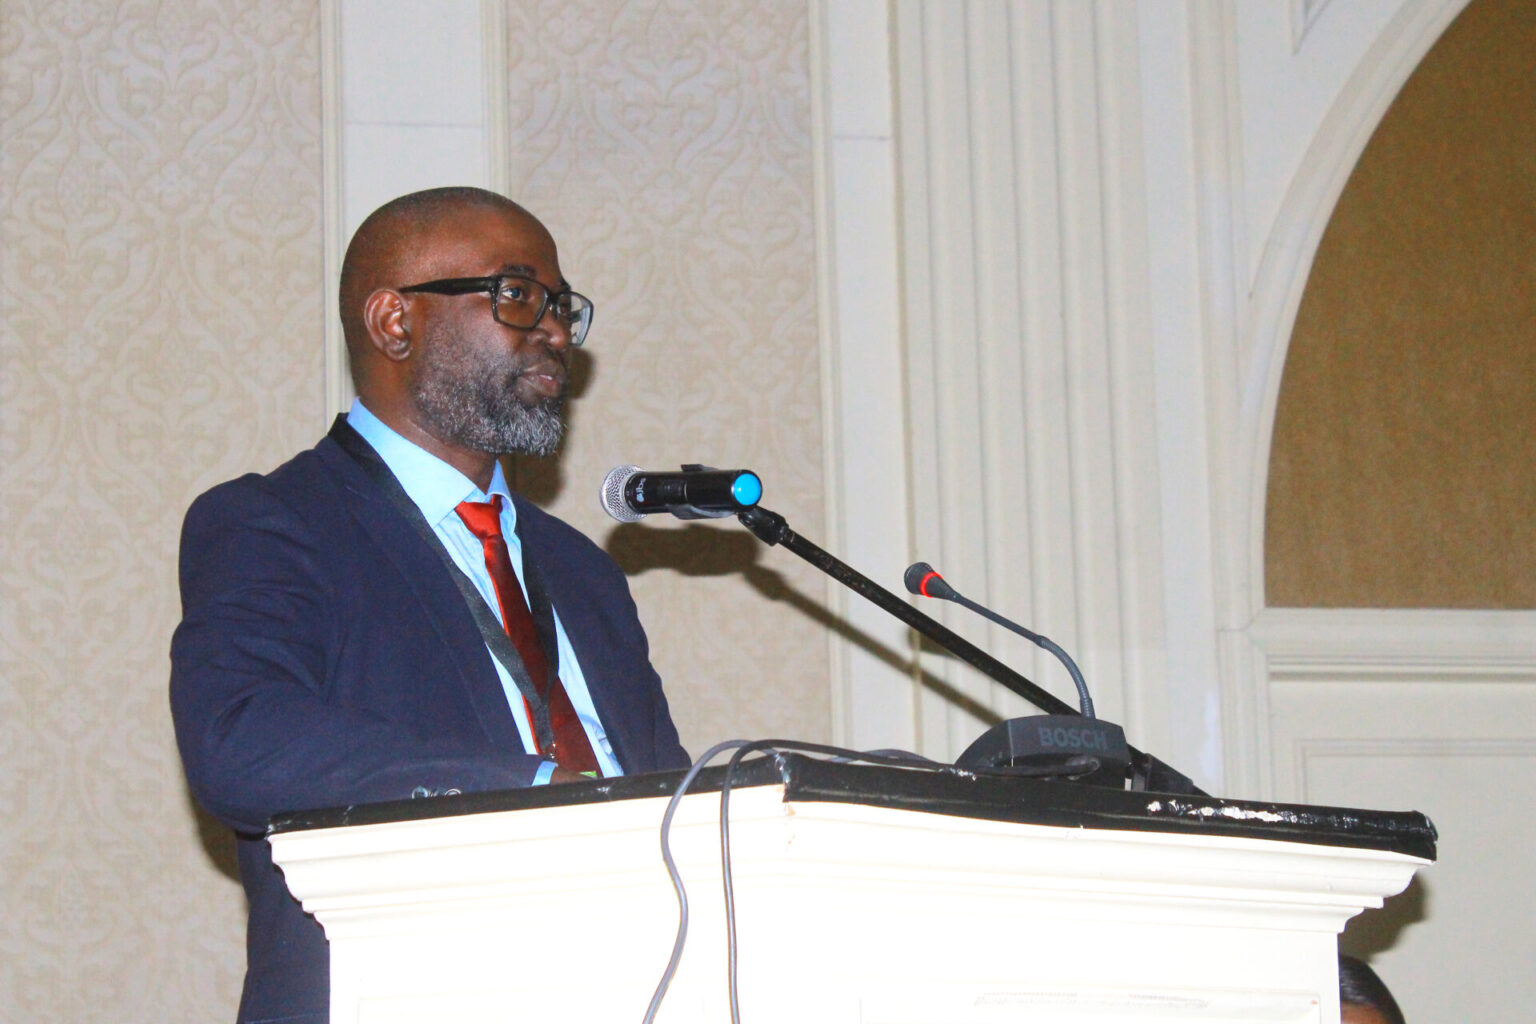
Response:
[315,438,522,749]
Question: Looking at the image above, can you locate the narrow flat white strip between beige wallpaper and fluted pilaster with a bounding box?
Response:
[809,0,915,749]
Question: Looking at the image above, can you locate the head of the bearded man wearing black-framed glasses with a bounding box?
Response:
[339,187,591,481]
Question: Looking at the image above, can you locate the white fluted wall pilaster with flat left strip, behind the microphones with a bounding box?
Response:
[813,3,1167,754]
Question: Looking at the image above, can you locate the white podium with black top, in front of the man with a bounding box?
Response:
[270,755,1435,1024]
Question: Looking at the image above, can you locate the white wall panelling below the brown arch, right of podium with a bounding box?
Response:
[1255,654,1536,1019]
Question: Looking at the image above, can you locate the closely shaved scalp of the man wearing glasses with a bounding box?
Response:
[339,186,542,393]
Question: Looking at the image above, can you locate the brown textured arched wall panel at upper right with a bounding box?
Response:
[1264,0,1536,609]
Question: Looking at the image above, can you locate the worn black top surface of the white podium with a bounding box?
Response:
[267,754,1436,860]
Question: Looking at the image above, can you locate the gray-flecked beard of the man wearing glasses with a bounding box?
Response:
[412,347,565,456]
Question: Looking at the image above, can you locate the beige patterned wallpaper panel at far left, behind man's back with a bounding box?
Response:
[0,0,323,1024]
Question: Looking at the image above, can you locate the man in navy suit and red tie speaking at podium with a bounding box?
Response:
[170,189,688,1021]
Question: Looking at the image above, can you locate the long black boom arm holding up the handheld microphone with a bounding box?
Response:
[736,505,1209,795]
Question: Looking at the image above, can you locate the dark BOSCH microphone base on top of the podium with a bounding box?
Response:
[955,715,1130,789]
